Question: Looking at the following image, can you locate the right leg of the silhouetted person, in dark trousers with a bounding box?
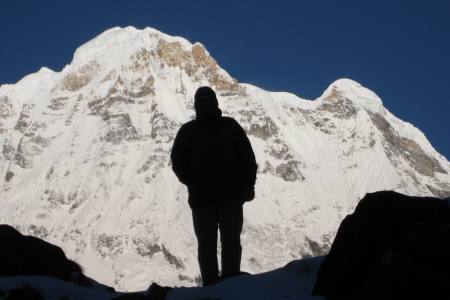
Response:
[219,201,243,278]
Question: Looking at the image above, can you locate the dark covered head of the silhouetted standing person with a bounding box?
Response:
[194,86,221,119]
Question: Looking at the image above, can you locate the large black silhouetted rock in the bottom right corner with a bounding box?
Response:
[313,191,450,299]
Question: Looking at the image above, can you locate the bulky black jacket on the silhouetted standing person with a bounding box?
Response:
[171,88,257,208]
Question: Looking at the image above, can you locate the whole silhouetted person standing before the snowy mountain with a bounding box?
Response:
[171,86,256,285]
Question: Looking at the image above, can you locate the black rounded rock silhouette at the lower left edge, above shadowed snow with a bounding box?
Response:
[0,225,87,283]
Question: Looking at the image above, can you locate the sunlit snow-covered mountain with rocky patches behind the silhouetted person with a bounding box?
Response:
[0,27,450,291]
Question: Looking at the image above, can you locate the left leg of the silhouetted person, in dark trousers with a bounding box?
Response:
[192,205,219,286]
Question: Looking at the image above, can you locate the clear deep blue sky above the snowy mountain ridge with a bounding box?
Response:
[0,0,450,158]
